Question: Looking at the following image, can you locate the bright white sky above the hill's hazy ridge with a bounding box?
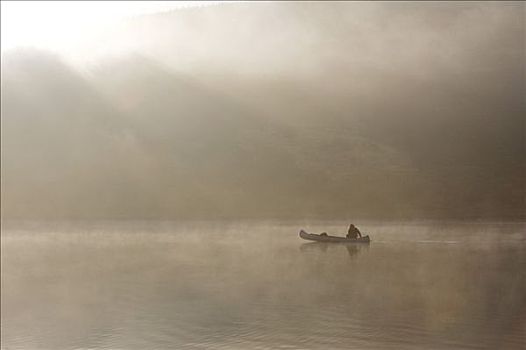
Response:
[1,1,217,54]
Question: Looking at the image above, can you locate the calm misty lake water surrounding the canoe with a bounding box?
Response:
[1,222,526,349]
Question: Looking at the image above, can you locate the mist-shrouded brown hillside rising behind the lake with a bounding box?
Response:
[1,3,526,219]
